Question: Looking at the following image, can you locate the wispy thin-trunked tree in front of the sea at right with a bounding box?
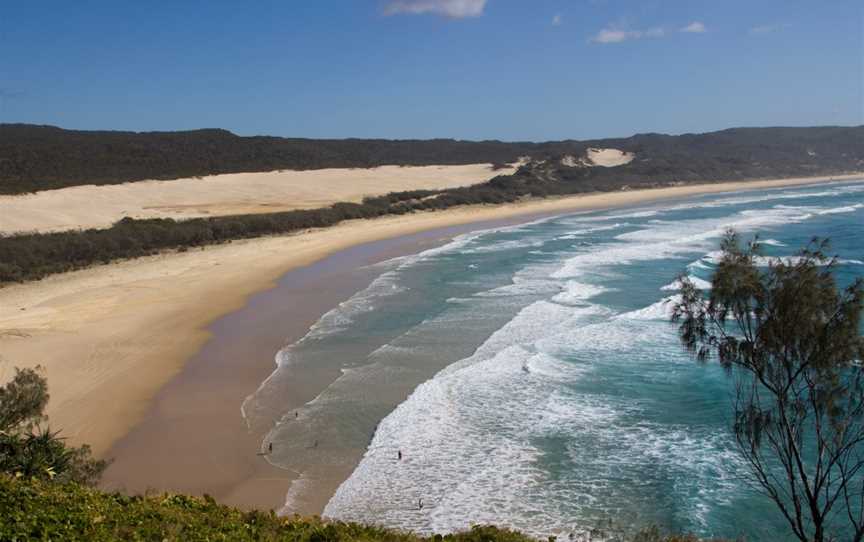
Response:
[673,232,864,542]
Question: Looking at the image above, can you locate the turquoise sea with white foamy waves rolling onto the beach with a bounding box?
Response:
[246,183,864,540]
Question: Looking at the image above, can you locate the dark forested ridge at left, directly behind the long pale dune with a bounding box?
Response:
[0,124,539,194]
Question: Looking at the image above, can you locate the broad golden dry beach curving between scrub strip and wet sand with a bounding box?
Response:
[0,175,860,508]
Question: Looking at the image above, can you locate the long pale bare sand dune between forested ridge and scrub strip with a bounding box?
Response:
[0,164,514,234]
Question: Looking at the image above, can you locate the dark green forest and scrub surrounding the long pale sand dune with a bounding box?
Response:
[0,125,864,283]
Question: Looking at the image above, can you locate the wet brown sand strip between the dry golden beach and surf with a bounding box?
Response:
[102,219,521,515]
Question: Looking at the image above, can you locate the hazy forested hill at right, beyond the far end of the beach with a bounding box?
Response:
[500,126,864,196]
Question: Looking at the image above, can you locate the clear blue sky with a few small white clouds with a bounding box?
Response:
[0,0,864,140]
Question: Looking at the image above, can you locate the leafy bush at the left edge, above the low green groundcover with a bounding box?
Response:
[0,369,107,486]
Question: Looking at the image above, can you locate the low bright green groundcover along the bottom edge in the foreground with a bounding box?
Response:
[0,475,724,542]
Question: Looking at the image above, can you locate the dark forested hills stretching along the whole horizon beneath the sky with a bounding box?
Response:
[0,124,864,194]
